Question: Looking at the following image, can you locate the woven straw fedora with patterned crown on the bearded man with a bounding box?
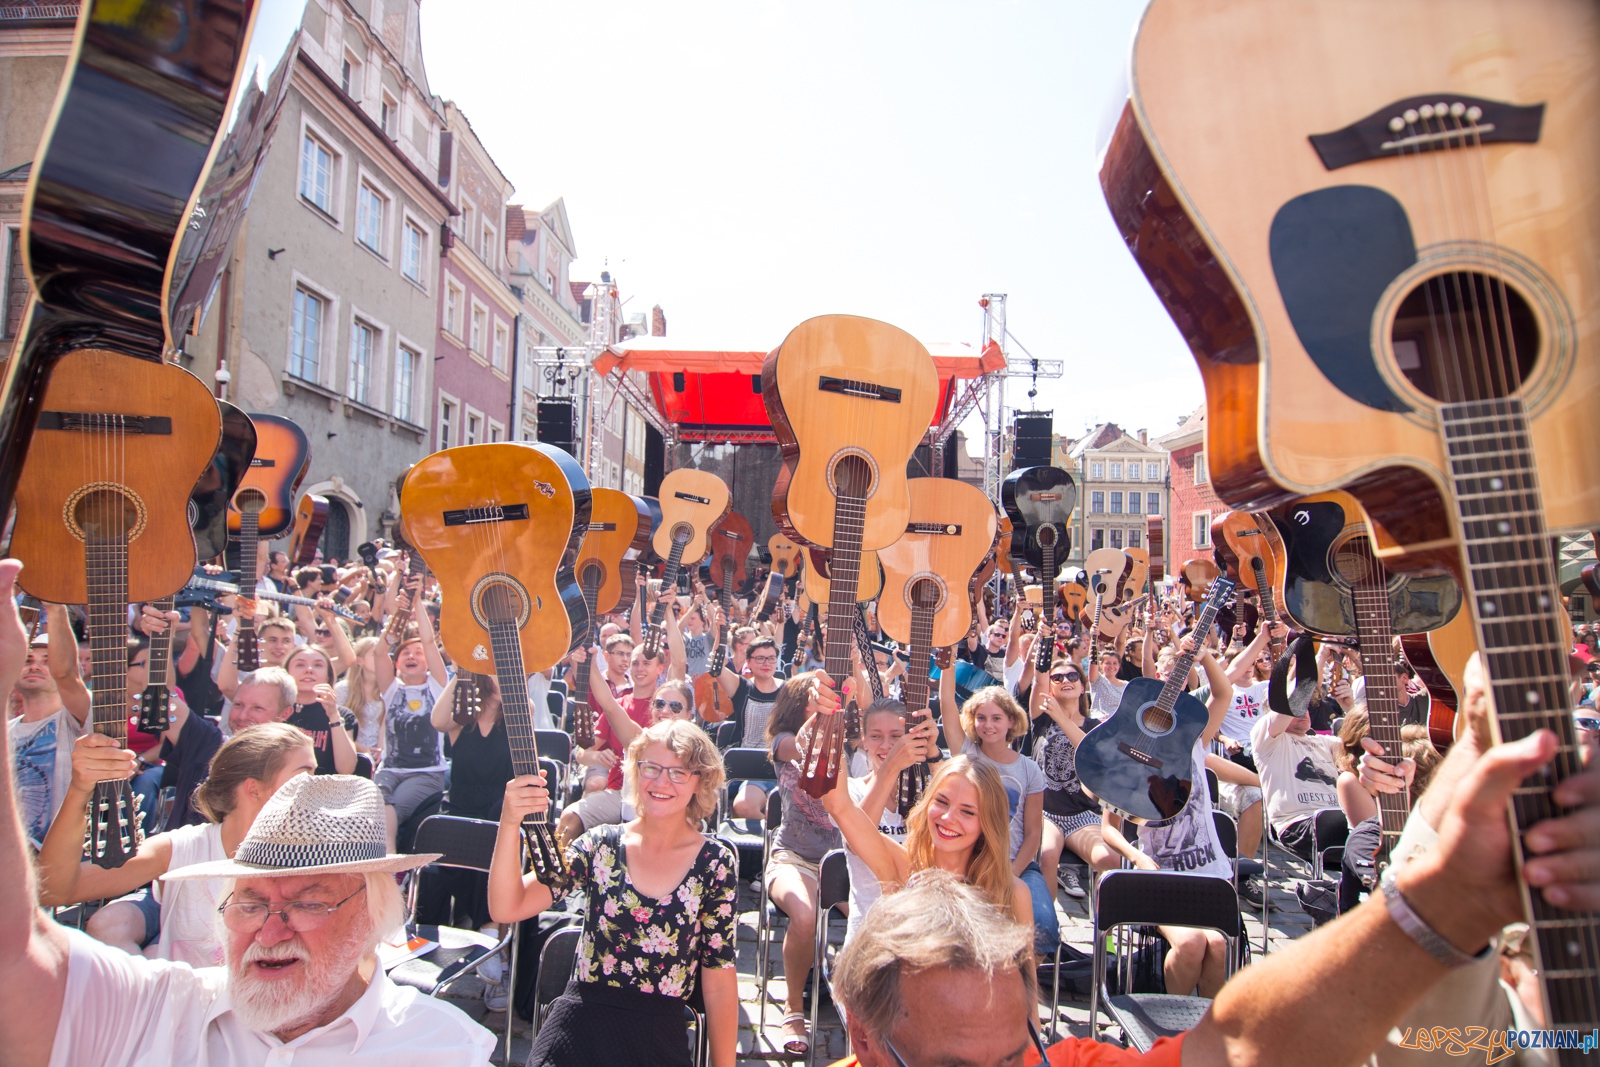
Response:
[162,774,440,881]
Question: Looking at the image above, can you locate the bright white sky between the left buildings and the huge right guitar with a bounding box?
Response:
[422,0,1203,435]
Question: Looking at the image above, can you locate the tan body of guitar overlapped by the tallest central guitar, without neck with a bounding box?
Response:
[878,478,1000,648]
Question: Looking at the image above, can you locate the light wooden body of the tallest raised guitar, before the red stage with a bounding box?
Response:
[762,315,939,550]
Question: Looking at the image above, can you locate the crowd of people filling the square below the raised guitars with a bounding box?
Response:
[0,544,1600,1067]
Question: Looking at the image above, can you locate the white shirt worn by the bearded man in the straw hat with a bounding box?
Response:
[50,929,494,1067]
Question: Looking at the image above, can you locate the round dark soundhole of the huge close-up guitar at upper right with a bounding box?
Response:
[1390,270,1539,403]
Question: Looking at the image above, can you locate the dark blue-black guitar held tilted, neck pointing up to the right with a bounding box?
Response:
[1075,577,1234,822]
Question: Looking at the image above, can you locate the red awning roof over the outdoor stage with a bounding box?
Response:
[595,338,1005,443]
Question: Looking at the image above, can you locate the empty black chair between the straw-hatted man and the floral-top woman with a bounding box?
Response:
[400,816,520,1054]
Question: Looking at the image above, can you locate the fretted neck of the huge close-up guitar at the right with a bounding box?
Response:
[1440,397,1600,1030]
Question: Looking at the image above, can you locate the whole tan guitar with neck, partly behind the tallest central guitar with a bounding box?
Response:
[878,478,1000,814]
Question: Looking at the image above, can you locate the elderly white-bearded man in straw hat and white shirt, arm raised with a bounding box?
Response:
[0,560,494,1067]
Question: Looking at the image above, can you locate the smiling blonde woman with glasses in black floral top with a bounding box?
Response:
[490,720,739,1067]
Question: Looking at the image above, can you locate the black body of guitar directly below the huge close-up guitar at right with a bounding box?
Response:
[1266,491,1461,637]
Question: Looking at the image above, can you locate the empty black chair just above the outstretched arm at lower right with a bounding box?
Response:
[1090,870,1243,1053]
